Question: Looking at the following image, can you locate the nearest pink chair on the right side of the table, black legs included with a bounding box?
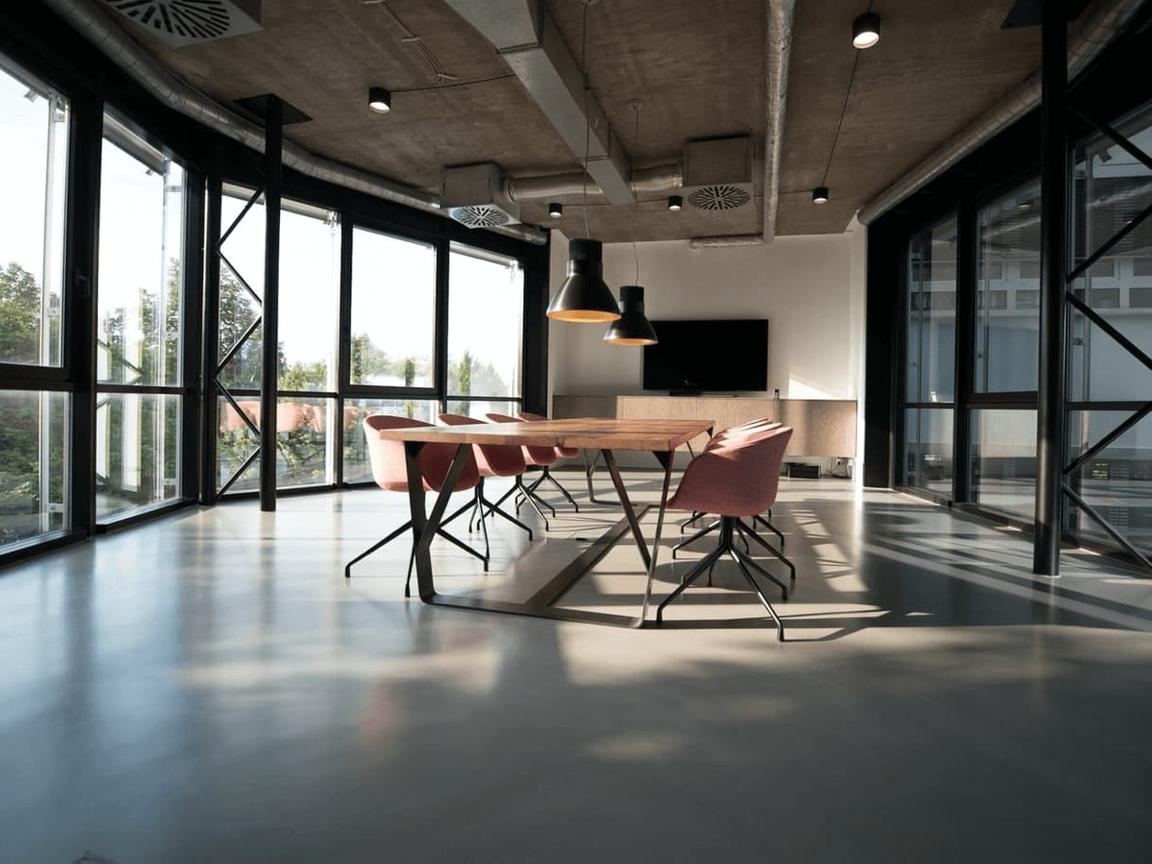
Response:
[655,426,796,642]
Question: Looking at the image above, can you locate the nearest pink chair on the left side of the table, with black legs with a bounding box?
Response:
[344,414,488,597]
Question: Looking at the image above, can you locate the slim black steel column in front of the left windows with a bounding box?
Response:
[260,96,283,511]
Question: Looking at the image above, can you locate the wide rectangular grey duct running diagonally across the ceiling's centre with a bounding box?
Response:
[446,0,635,204]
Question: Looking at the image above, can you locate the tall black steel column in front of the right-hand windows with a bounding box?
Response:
[1032,0,1068,576]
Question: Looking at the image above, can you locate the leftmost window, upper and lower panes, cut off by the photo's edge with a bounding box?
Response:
[0,56,71,552]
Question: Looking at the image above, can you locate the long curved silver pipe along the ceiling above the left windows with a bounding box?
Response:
[44,0,546,244]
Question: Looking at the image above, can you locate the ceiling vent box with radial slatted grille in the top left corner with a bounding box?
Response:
[104,0,262,48]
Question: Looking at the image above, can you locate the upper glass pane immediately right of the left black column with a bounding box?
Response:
[280,210,340,391]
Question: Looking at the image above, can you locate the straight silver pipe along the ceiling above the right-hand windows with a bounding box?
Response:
[857,0,1144,225]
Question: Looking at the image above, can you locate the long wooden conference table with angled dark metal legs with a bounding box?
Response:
[373,419,713,627]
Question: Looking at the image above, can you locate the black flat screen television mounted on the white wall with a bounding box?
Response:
[644,318,768,393]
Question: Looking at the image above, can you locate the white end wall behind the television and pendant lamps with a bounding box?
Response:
[548,228,866,399]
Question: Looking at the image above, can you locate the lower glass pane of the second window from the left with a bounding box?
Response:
[96,393,183,521]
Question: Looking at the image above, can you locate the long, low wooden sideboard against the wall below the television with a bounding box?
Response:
[552,395,856,458]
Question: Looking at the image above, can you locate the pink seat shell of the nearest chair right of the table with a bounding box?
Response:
[668,426,793,516]
